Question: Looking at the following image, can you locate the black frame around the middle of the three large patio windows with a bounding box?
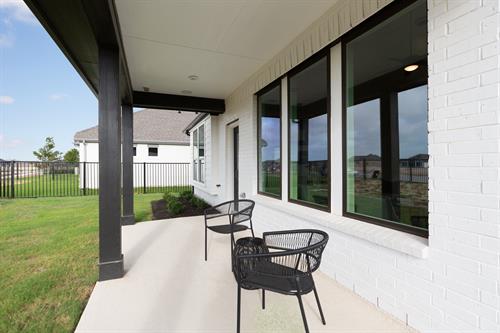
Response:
[286,50,330,213]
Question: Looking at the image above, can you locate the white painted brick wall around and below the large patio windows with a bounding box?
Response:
[193,0,500,333]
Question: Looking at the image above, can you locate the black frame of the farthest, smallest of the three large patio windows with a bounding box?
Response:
[255,78,283,200]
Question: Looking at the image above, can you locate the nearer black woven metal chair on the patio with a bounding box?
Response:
[233,229,328,333]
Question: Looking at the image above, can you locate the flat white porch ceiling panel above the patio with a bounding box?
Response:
[116,0,337,98]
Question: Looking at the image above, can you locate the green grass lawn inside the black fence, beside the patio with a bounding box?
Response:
[0,193,162,332]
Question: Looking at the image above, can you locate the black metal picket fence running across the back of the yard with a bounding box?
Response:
[0,161,191,198]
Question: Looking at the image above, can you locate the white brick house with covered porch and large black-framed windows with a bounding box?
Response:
[30,0,500,333]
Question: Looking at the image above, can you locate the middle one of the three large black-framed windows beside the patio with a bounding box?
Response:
[288,55,330,210]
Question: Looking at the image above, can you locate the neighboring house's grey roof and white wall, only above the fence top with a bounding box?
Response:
[74,109,196,163]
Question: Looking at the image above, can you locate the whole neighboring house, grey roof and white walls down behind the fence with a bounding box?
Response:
[74,109,196,189]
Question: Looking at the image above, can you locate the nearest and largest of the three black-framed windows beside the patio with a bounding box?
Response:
[344,0,429,236]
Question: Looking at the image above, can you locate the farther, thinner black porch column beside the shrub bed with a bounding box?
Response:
[122,105,135,225]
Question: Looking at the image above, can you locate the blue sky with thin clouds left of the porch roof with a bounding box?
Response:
[0,0,97,160]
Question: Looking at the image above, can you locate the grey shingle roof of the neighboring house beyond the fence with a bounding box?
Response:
[74,109,197,144]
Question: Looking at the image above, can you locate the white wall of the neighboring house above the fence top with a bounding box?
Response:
[78,142,191,163]
